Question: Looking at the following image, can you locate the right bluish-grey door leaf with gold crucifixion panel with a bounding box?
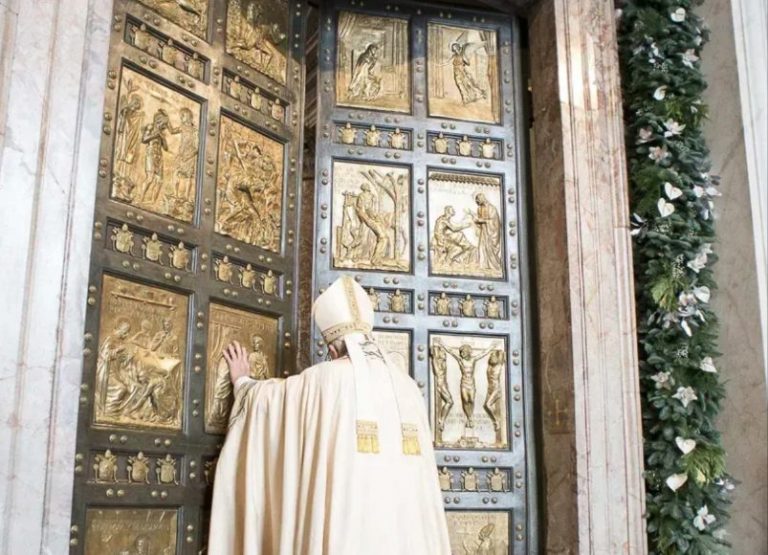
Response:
[313,0,536,553]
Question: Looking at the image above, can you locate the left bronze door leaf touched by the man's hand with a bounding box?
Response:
[70,0,308,555]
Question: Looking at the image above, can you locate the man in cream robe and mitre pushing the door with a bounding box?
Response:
[209,277,450,555]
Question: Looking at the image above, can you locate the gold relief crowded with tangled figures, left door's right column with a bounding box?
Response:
[215,116,284,252]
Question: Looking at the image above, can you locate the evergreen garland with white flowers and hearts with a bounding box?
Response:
[618,0,733,555]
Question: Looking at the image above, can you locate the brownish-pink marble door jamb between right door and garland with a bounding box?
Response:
[529,0,646,555]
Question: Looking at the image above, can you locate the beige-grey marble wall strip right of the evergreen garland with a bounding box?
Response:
[698,0,768,553]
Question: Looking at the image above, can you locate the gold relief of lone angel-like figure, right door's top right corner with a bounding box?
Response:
[427,23,499,123]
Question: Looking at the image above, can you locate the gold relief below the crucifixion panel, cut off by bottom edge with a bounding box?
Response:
[445,511,510,555]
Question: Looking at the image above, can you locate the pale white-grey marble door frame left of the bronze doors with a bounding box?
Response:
[0,0,112,554]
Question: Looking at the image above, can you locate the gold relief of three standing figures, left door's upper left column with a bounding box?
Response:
[111,67,200,222]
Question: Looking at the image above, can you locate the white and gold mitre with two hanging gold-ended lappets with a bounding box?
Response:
[312,276,421,455]
